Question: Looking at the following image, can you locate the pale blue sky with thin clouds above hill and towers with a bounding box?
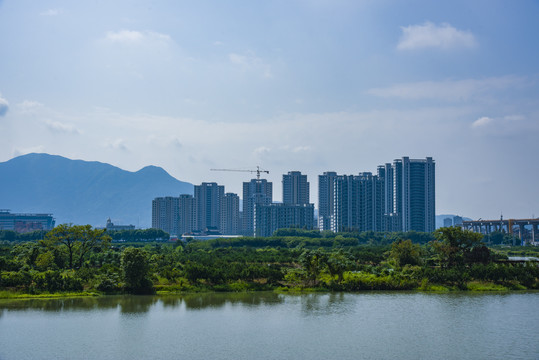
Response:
[0,0,539,219]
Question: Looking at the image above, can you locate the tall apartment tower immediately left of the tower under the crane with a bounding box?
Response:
[195,182,225,231]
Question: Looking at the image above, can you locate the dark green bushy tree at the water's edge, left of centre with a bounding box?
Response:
[121,247,153,294]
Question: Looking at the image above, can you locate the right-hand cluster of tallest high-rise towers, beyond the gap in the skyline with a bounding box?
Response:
[318,157,436,232]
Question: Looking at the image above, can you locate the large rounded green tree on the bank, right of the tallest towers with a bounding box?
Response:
[431,226,483,267]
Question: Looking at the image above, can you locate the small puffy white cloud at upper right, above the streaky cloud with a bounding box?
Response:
[397,21,477,50]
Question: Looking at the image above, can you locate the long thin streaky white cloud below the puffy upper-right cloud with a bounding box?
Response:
[367,76,526,101]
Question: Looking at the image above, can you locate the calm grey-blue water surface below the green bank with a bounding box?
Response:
[0,292,539,360]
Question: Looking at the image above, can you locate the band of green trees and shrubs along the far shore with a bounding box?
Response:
[0,224,539,299]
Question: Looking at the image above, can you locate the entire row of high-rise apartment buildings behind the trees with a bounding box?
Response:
[152,156,436,236]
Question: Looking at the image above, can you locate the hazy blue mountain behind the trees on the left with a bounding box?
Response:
[0,154,193,228]
